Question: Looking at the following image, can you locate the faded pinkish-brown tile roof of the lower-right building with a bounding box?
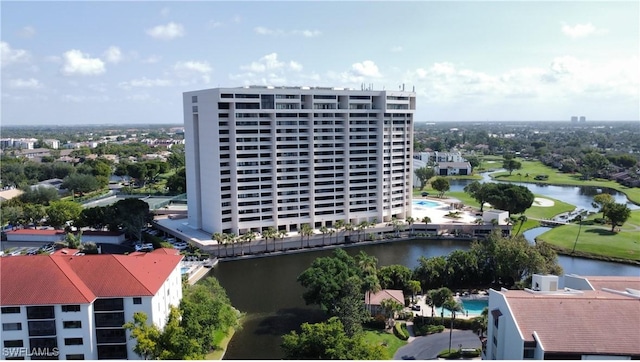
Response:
[505,277,640,356]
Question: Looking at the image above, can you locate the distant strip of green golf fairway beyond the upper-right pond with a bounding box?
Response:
[491,159,640,204]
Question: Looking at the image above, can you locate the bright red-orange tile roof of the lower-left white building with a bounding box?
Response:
[0,251,182,305]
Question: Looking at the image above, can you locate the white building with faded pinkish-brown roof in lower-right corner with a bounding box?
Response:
[483,274,640,360]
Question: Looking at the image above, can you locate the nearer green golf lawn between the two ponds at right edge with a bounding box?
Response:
[537,210,640,262]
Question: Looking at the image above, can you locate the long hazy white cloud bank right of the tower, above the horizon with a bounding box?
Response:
[404,56,640,106]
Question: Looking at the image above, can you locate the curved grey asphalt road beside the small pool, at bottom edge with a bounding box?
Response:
[393,330,482,359]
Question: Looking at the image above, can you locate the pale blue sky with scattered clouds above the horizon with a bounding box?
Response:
[0,1,640,125]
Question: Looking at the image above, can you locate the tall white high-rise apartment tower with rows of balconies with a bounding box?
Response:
[183,86,416,234]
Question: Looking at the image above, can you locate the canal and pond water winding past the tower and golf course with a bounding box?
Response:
[210,175,640,360]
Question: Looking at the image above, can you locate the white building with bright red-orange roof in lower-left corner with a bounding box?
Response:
[0,249,182,360]
